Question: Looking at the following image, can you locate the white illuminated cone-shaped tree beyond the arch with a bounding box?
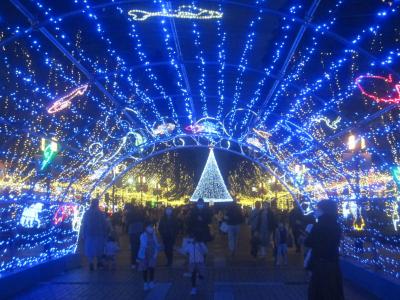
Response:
[190,149,233,202]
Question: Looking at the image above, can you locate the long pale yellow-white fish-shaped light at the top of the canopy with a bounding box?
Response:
[128,5,223,21]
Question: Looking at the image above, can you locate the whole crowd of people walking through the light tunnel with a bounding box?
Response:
[81,199,343,299]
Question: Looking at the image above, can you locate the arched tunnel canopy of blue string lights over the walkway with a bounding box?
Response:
[0,0,400,278]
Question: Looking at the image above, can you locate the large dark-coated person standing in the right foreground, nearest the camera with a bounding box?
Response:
[304,200,344,300]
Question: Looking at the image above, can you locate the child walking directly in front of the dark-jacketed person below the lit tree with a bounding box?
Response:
[181,237,208,295]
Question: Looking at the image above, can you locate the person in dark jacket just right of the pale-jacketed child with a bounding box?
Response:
[158,206,179,267]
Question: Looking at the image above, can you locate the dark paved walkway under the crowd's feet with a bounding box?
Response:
[16,228,374,300]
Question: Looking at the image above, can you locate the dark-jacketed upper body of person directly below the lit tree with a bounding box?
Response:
[187,198,212,243]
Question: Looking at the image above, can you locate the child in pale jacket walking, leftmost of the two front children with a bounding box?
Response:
[137,223,160,291]
